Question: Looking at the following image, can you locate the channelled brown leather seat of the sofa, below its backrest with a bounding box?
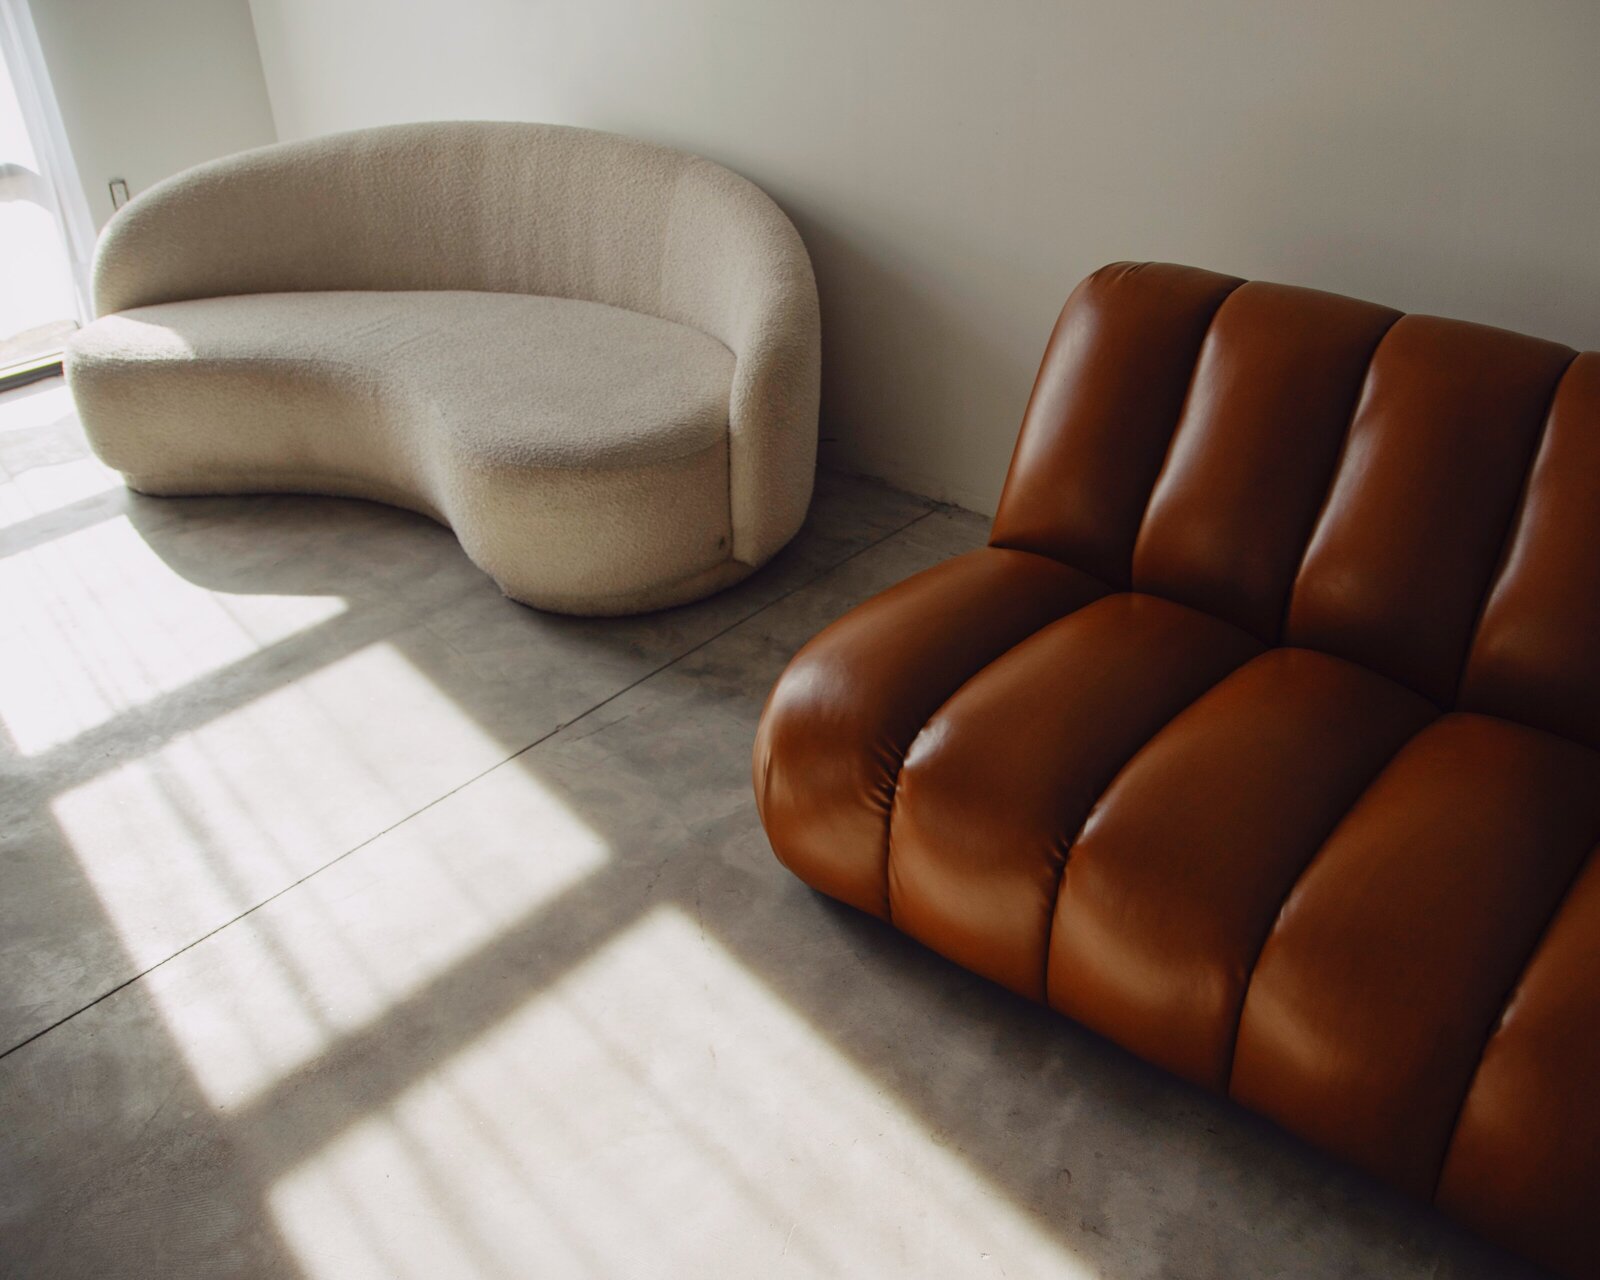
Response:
[755,547,1600,1202]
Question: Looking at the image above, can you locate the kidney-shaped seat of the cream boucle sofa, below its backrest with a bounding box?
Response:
[64,291,733,611]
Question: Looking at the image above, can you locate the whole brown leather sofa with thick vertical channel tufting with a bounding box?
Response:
[755,264,1600,1277]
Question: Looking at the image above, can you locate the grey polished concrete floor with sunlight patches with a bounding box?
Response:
[0,381,1530,1280]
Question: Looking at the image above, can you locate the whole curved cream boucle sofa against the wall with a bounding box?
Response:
[66,123,821,614]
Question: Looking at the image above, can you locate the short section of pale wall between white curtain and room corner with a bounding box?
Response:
[32,0,277,224]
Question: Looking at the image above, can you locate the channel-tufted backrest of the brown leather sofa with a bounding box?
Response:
[990,264,1600,746]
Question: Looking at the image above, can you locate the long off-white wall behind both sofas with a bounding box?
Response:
[251,0,1600,510]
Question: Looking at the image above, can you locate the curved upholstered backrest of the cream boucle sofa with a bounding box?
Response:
[94,122,792,346]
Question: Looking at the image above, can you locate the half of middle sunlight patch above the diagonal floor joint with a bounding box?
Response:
[51,643,563,966]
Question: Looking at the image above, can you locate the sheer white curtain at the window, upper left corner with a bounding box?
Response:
[0,0,94,322]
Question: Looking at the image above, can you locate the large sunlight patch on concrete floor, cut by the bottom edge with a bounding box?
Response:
[270,907,1093,1280]
